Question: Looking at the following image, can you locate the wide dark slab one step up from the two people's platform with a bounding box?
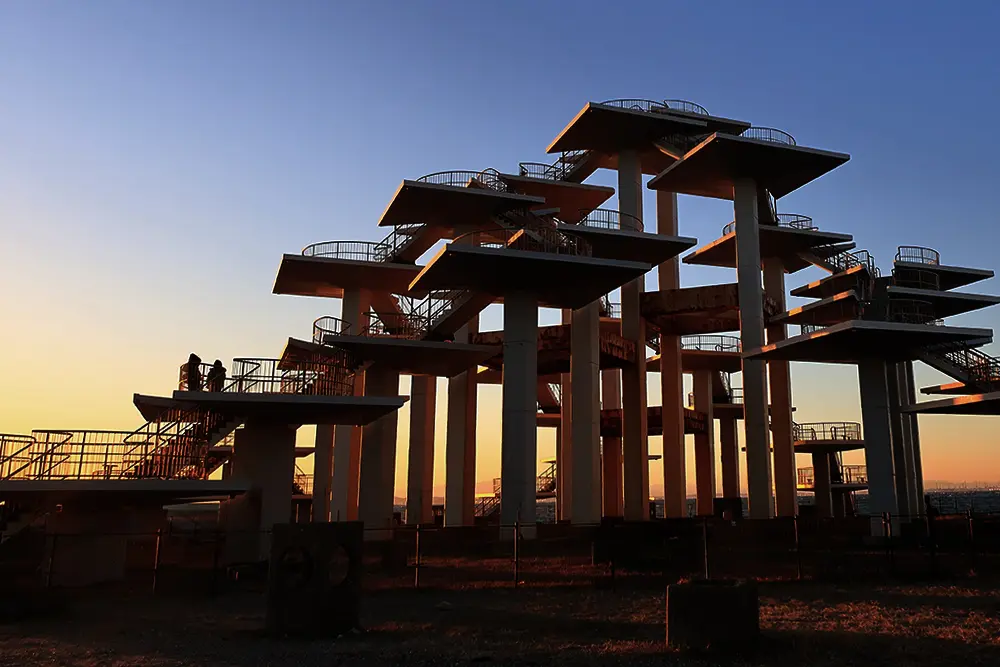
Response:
[282,334,499,378]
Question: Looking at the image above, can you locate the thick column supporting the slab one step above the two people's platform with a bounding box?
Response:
[358,367,399,539]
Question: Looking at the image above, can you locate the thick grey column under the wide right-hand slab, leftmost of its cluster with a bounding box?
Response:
[858,359,898,534]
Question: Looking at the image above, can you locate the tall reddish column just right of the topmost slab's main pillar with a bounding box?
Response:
[656,191,687,517]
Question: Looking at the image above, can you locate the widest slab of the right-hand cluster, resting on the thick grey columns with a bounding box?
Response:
[743,320,992,364]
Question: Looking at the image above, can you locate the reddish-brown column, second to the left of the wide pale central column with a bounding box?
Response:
[406,375,437,525]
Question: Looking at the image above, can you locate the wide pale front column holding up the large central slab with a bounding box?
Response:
[500,293,540,536]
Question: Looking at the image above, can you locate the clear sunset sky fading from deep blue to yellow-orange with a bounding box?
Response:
[0,0,1000,500]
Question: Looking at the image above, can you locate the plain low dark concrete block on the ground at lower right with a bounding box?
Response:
[667,580,760,652]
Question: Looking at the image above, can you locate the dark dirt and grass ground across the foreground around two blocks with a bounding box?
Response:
[0,583,1000,667]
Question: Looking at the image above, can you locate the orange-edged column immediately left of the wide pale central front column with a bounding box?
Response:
[444,316,479,526]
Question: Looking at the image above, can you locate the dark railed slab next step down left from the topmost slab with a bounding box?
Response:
[378,181,545,228]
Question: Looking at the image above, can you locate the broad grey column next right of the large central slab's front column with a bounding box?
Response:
[570,301,601,524]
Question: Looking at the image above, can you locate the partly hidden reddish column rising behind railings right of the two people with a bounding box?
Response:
[330,290,371,521]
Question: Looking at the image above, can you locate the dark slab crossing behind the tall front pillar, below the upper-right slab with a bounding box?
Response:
[684,225,853,273]
